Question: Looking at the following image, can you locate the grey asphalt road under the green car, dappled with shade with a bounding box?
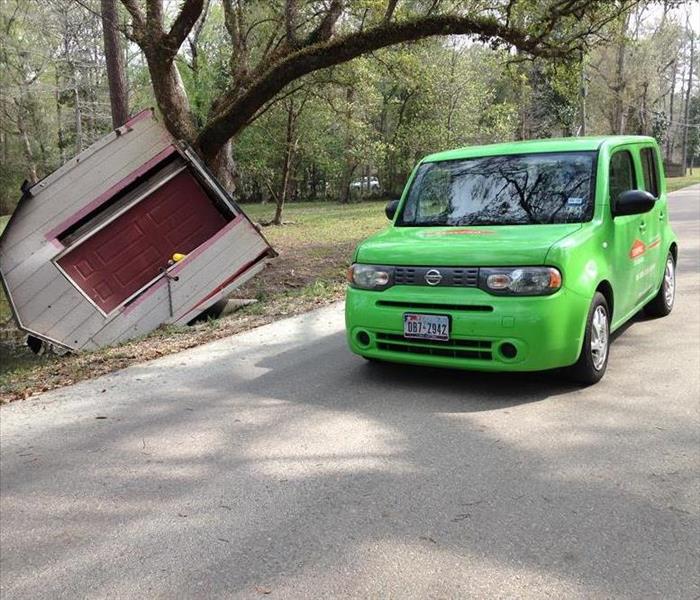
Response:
[0,187,700,600]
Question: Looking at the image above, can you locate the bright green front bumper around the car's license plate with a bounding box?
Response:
[345,285,590,371]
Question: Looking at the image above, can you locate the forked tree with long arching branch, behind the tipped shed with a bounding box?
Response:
[121,0,638,185]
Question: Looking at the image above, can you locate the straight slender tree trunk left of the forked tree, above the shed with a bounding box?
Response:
[100,0,129,129]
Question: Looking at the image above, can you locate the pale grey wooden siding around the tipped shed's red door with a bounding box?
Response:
[0,114,269,350]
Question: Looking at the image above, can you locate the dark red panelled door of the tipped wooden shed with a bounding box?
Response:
[58,170,227,313]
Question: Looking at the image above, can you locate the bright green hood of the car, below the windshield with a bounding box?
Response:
[355,223,582,266]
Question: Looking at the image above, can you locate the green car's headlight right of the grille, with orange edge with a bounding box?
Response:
[479,267,561,296]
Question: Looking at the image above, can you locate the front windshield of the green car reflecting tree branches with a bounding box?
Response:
[397,152,595,226]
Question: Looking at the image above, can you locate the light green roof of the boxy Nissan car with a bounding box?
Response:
[421,135,656,162]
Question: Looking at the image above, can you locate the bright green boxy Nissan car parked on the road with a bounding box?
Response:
[345,136,678,384]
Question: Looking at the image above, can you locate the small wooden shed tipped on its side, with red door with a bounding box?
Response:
[0,110,274,350]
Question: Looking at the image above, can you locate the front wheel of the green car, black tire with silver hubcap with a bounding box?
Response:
[568,292,610,385]
